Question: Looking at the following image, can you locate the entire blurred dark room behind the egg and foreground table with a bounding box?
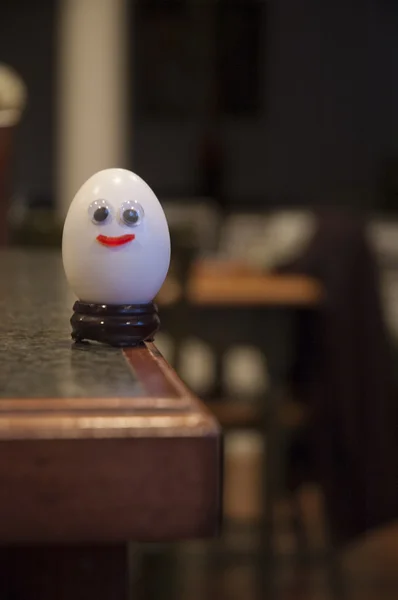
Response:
[0,0,398,600]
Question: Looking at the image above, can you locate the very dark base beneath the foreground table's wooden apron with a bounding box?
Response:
[0,545,129,600]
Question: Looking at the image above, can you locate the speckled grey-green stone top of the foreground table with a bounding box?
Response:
[0,250,145,399]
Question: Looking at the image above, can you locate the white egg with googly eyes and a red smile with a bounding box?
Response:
[62,169,170,305]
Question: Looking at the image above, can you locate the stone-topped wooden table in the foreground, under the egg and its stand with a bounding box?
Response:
[0,251,221,600]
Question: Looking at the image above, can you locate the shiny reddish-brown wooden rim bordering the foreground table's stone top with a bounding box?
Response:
[0,343,220,442]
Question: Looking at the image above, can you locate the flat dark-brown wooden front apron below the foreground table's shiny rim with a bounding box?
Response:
[0,434,222,544]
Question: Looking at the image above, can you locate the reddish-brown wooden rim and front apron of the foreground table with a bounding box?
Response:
[0,344,222,544]
